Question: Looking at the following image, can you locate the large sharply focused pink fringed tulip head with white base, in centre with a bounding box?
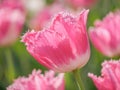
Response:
[22,10,90,72]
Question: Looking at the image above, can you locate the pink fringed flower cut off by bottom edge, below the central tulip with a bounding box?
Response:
[7,70,65,90]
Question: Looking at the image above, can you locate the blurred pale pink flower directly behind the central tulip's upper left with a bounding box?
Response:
[29,3,63,30]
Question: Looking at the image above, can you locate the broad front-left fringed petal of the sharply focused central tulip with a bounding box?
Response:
[23,30,75,72]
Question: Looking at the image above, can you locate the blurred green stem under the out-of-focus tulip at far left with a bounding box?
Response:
[5,48,15,83]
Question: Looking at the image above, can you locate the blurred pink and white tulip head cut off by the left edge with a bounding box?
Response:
[0,2,25,46]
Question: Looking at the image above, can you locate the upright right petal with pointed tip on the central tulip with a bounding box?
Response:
[51,10,89,54]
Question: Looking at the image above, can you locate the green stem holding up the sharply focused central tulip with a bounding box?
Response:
[73,69,85,90]
